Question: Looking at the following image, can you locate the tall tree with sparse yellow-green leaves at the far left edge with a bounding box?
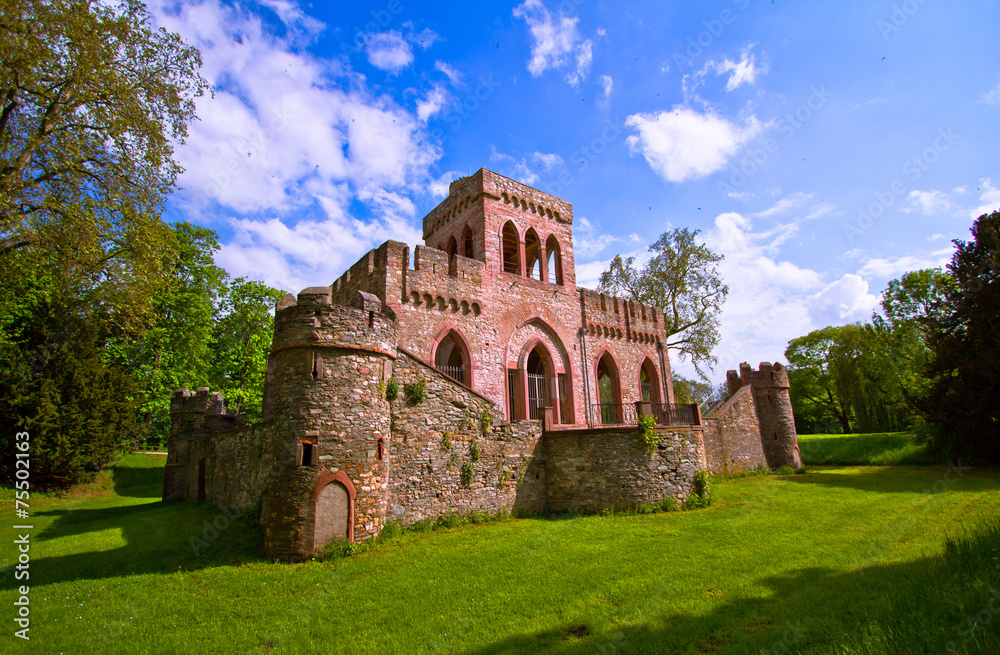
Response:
[0,0,206,484]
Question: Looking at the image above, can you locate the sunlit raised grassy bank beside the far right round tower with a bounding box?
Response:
[799,432,942,466]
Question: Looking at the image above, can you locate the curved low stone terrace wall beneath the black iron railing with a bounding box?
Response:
[545,427,704,512]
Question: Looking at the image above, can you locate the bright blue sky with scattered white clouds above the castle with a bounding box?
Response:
[151,0,1000,378]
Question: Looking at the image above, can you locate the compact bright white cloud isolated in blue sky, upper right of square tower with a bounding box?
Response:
[625,106,761,182]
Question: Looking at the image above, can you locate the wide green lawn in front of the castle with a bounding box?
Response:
[0,455,1000,655]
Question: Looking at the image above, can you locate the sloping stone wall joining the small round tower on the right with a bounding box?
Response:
[702,386,767,475]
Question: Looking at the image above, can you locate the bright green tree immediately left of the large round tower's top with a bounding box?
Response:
[213,277,284,423]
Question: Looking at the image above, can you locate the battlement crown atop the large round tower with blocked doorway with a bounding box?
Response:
[271,287,397,357]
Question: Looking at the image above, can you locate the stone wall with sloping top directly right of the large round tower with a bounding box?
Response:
[386,351,545,525]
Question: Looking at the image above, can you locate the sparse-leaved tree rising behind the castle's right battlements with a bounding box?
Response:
[600,228,729,377]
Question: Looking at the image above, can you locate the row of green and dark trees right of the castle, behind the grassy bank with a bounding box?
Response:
[785,212,1000,463]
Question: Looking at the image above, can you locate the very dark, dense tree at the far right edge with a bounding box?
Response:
[919,212,1000,464]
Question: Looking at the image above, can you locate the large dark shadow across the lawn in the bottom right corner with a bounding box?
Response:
[463,521,1000,655]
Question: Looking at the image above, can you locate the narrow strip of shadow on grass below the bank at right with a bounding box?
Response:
[783,466,1000,494]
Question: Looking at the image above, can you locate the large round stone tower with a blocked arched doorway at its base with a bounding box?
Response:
[262,287,397,559]
